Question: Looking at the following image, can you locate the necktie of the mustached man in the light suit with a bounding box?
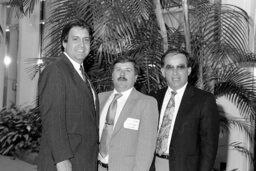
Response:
[100,93,122,158]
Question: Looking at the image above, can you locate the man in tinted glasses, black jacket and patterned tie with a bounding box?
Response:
[151,50,219,171]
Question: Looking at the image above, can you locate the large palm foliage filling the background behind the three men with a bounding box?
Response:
[0,0,256,166]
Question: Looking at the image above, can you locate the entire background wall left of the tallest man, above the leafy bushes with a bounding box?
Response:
[0,3,39,109]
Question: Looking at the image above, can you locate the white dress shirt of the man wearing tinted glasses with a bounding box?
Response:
[158,83,187,154]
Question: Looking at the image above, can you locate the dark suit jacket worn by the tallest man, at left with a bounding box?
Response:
[38,54,99,171]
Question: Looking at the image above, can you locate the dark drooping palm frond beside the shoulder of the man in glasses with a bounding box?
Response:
[210,66,256,121]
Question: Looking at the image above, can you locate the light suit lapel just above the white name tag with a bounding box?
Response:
[112,88,138,137]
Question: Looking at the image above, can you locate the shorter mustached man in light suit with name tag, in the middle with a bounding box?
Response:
[98,57,158,171]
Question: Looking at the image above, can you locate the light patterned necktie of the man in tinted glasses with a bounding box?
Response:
[156,91,177,155]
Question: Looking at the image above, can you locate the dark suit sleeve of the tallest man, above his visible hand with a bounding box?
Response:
[39,67,73,164]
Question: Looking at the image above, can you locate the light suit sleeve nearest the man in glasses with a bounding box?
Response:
[133,98,158,171]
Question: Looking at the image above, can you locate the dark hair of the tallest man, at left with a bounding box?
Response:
[61,19,91,52]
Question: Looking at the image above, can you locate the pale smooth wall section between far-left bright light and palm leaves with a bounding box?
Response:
[17,3,39,106]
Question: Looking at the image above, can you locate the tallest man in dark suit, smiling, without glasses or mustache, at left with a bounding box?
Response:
[38,20,99,171]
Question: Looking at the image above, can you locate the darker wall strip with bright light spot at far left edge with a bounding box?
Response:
[0,6,19,107]
